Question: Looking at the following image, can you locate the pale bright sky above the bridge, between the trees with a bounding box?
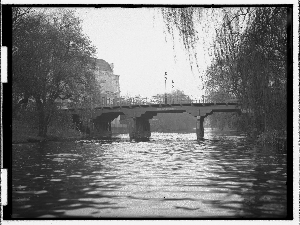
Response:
[76,8,213,98]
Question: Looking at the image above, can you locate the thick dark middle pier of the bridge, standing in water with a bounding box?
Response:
[128,117,151,141]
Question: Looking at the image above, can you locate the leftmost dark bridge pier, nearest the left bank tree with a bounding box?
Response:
[91,119,112,139]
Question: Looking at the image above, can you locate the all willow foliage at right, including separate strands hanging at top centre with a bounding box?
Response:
[162,7,288,137]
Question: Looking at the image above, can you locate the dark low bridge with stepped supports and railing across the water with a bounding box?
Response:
[66,98,241,140]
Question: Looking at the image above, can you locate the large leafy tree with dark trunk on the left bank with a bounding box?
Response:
[12,10,95,137]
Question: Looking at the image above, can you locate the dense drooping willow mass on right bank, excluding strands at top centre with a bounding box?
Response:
[207,7,287,132]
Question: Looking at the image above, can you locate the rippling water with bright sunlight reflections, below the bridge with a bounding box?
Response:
[12,131,286,218]
